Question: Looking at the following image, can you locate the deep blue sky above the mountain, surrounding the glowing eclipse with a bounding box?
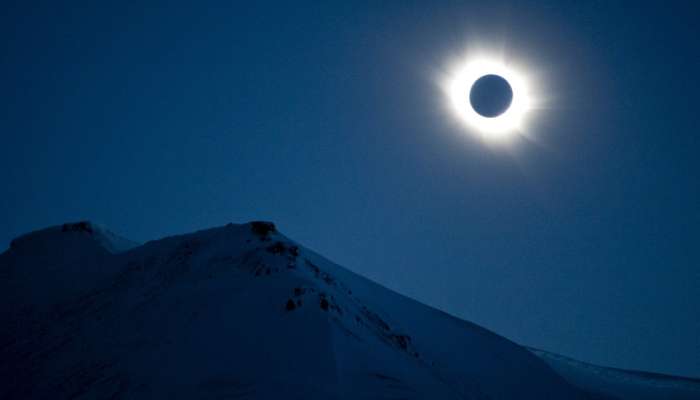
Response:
[0,1,700,376]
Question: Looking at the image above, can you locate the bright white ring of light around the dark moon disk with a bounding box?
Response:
[442,58,533,141]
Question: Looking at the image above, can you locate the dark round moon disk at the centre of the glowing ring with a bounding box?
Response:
[469,75,513,118]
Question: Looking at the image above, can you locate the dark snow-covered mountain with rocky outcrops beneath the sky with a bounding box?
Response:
[0,222,700,400]
